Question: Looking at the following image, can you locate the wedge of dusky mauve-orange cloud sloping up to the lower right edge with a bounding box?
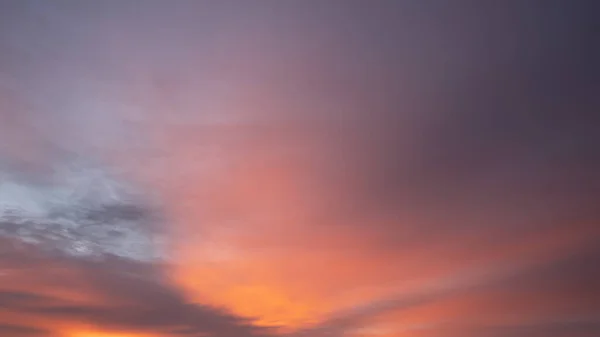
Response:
[294,232,600,336]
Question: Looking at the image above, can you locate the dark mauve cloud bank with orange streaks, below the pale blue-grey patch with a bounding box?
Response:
[0,247,269,337]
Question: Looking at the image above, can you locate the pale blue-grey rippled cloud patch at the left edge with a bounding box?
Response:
[0,159,166,261]
